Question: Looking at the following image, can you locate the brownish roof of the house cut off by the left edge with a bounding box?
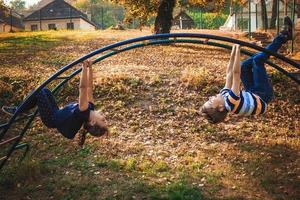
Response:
[0,6,24,29]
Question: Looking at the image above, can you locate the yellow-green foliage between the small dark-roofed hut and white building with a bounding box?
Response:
[188,10,228,29]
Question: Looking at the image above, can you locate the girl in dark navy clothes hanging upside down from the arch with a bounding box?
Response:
[2,61,108,139]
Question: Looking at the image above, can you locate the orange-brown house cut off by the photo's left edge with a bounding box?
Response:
[0,6,24,32]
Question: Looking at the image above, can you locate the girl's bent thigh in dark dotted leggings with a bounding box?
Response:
[37,89,58,128]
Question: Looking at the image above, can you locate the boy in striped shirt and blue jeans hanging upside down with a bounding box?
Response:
[201,17,293,123]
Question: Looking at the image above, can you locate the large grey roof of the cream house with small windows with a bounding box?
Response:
[24,0,96,26]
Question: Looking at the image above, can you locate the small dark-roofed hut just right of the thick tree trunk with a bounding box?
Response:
[173,10,194,29]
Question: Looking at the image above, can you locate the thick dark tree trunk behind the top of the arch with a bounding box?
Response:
[154,0,176,34]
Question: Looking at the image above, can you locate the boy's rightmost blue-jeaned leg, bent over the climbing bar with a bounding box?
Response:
[252,34,286,102]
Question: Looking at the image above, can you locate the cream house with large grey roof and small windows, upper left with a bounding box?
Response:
[23,0,96,31]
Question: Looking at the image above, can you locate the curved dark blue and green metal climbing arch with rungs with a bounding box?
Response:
[0,33,300,169]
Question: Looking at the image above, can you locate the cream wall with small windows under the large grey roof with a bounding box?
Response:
[24,18,95,31]
